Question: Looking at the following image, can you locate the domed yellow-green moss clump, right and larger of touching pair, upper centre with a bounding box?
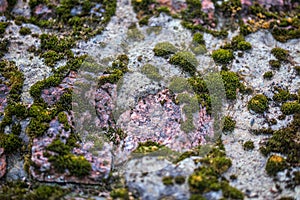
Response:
[169,51,199,76]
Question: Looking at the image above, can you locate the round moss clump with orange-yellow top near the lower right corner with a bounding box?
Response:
[266,155,287,176]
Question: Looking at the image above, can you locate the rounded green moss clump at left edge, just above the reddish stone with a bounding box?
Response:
[0,133,22,154]
